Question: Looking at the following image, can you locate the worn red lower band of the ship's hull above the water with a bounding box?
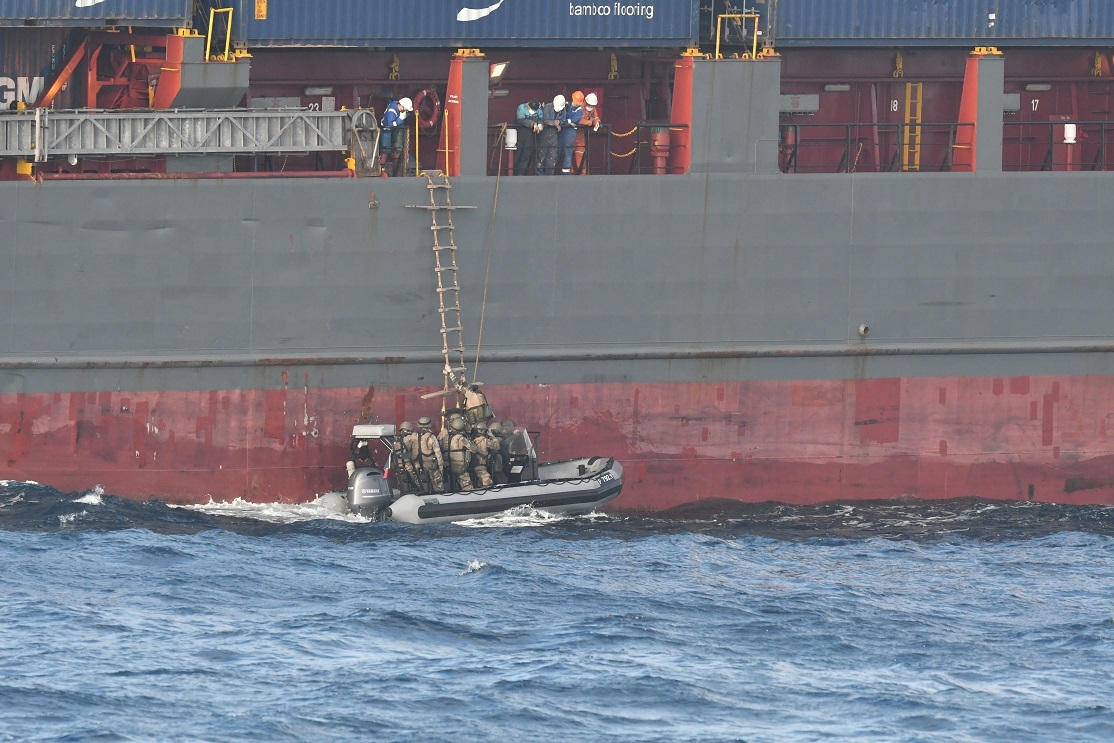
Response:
[0,375,1114,510]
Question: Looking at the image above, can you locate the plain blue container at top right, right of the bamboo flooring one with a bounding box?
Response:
[766,0,1114,47]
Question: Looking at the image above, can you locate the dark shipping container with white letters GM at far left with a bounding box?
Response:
[0,28,77,110]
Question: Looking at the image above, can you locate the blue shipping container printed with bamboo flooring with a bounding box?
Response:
[236,0,700,48]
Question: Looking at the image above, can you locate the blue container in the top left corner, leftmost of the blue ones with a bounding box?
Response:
[0,0,194,27]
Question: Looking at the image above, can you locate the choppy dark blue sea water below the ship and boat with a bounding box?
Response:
[0,482,1114,742]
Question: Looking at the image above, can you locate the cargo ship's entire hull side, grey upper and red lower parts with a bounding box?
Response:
[0,173,1114,509]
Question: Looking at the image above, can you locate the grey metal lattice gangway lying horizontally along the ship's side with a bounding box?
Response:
[0,108,379,163]
